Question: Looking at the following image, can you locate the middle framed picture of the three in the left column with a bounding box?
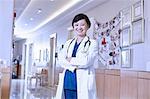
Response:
[121,26,131,47]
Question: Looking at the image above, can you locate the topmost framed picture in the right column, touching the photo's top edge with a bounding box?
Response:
[132,0,144,21]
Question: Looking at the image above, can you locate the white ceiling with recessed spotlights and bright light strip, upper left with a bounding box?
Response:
[14,0,109,37]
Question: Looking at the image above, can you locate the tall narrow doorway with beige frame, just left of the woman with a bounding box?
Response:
[48,33,57,87]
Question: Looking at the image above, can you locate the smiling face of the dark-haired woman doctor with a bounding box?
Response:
[73,19,89,37]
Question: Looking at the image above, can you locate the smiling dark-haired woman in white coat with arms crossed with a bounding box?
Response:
[56,13,98,99]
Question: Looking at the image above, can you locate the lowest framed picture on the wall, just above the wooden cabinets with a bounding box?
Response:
[121,49,132,68]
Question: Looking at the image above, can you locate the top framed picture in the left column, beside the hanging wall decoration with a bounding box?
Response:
[121,7,131,28]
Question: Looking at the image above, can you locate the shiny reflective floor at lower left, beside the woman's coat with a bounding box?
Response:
[10,79,55,99]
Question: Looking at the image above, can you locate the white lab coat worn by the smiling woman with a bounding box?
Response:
[56,36,98,99]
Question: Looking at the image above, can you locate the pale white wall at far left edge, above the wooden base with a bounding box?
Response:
[0,0,14,66]
